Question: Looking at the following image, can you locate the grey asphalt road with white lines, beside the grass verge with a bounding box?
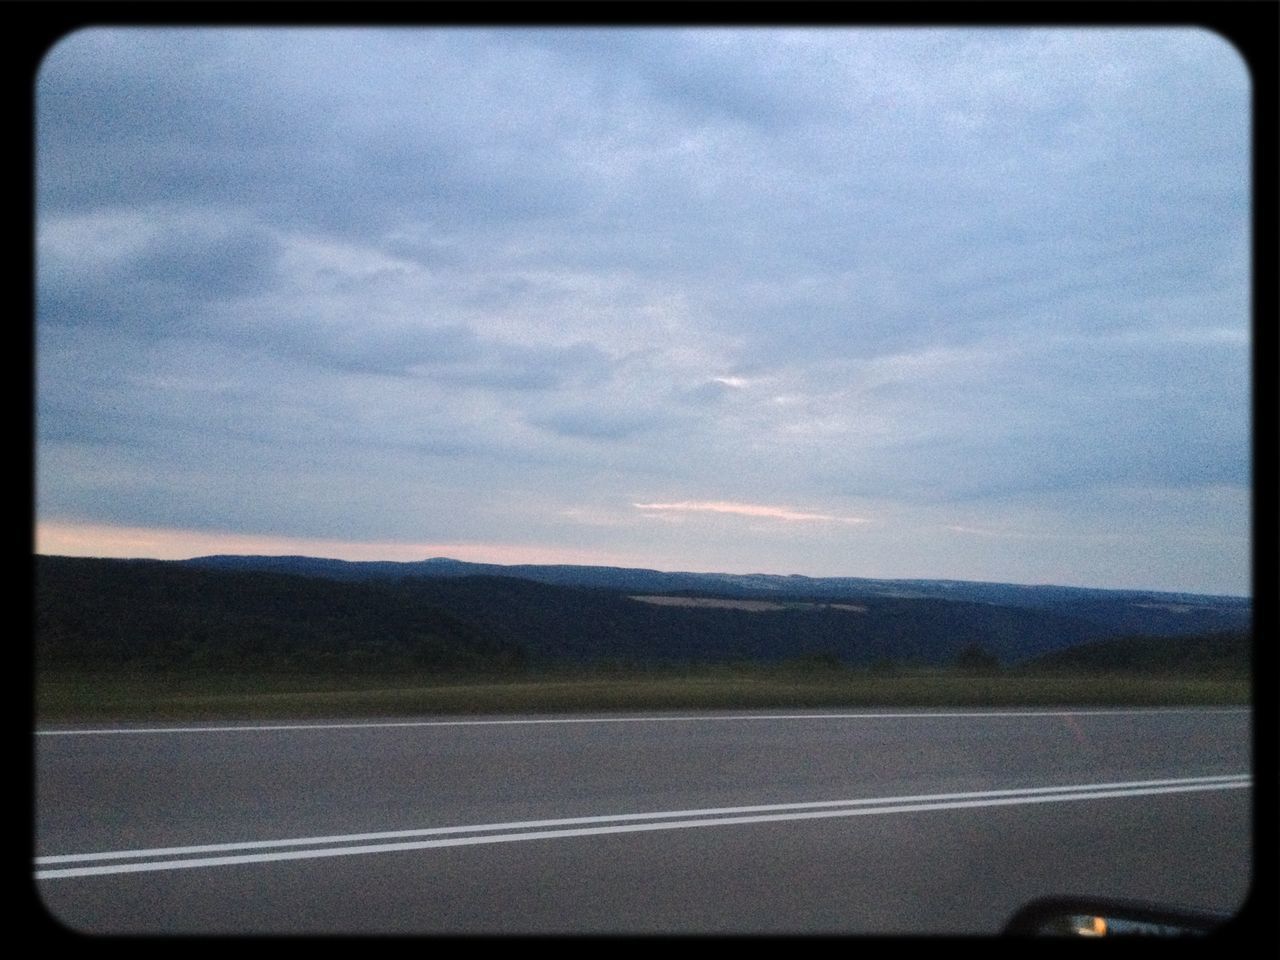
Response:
[33,708,1253,934]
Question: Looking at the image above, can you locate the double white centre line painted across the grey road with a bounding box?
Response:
[36,774,1253,879]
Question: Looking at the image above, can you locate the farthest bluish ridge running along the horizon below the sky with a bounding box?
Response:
[183,556,1253,637]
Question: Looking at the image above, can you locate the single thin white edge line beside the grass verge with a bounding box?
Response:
[36,707,1251,737]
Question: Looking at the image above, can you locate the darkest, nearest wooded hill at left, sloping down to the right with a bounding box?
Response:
[35,557,524,672]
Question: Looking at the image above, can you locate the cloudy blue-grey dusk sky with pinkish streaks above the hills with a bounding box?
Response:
[35,28,1251,594]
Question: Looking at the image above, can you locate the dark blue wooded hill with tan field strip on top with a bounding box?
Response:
[360,577,1091,664]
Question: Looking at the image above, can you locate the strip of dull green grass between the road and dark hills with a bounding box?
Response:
[35,667,1251,723]
